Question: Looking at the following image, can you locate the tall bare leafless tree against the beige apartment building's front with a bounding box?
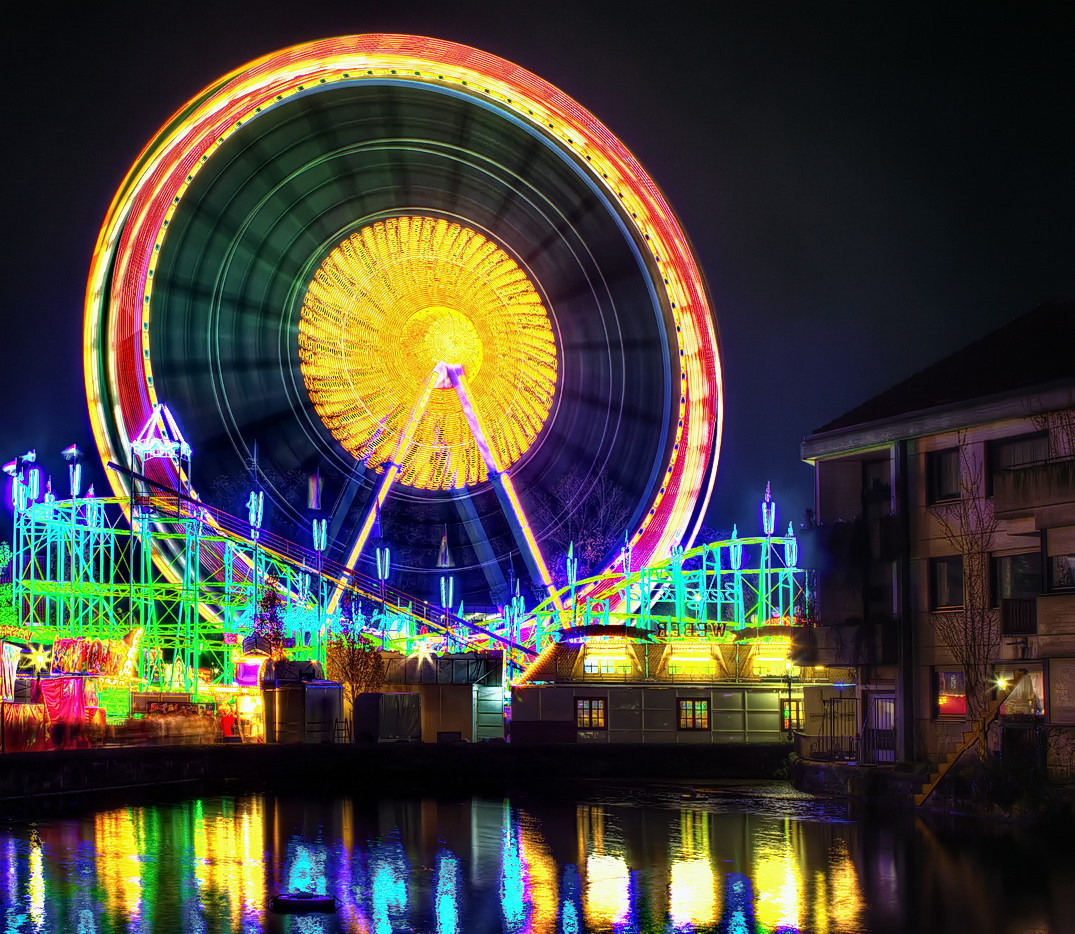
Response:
[929,431,1001,720]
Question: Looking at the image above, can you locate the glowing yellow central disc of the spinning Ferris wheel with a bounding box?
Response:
[299,216,559,489]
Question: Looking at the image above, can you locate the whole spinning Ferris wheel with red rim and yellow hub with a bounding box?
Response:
[86,35,722,605]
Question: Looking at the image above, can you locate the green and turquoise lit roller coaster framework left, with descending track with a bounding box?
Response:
[12,482,507,691]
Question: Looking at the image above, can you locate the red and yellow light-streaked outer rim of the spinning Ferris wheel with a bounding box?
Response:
[84,34,723,588]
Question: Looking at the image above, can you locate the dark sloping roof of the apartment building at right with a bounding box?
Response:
[813,302,1075,435]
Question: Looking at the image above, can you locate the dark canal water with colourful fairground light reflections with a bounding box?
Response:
[0,782,1075,934]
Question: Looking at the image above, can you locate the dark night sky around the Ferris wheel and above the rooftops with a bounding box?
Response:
[0,0,1075,530]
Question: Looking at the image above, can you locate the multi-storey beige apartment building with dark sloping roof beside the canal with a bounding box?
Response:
[800,303,1075,768]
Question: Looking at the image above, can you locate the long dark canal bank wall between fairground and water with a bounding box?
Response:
[0,743,788,810]
